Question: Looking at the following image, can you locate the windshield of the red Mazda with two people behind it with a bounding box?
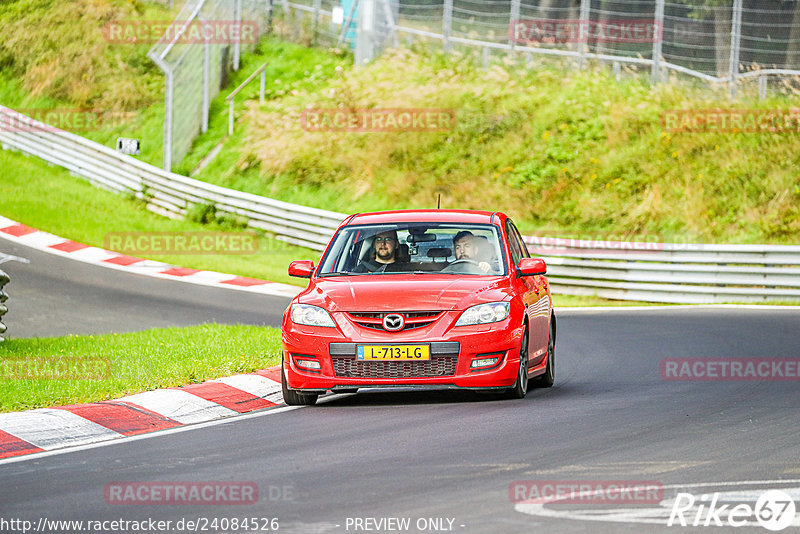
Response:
[319,223,506,276]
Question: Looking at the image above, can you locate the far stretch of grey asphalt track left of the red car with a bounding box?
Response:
[0,238,289,338]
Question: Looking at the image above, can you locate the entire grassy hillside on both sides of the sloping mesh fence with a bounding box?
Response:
[0,0,800,243]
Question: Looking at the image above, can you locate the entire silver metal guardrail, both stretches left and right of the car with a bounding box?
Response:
[0,106,800,303]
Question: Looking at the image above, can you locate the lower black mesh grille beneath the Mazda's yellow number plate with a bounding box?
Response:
[331,355,458,378]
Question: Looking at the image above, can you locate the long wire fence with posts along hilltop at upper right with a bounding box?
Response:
[284,0,800,96]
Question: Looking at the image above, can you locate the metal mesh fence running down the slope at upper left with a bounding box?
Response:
[148,0,272,170]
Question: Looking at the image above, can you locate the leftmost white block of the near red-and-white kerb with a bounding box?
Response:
[0,408,122,450]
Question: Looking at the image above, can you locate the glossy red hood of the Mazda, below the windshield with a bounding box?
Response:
[298,275,511,312]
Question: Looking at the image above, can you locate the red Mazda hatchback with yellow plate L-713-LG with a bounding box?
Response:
[282,210,556,405]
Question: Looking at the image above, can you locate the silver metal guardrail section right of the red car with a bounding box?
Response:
[525,237,800,304]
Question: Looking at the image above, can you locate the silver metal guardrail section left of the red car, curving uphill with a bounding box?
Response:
[0,106,345,254]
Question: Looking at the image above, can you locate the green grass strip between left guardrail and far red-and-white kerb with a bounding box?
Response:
[0,150,319,285]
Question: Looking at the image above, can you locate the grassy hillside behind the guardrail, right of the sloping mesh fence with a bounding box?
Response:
[188,50,800,243]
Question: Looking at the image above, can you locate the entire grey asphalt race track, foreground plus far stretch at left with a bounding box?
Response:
[0,242,800,533]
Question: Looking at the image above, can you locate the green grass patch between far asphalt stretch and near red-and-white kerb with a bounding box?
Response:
[0,324,281,412]
